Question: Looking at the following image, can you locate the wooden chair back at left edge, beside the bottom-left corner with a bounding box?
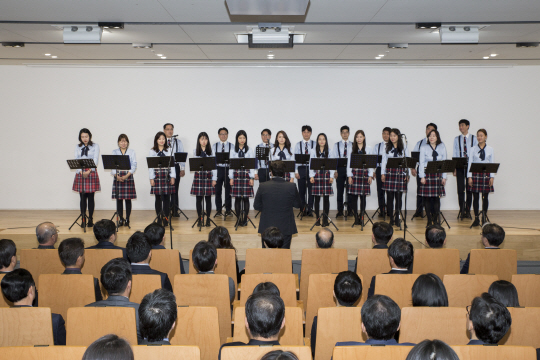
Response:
[0,307,54,346]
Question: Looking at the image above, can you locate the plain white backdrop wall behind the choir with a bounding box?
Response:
[0,66,540,210]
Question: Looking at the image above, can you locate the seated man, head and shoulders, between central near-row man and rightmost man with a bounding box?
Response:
[336,295,415,346]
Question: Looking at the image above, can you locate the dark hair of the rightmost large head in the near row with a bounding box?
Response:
[469,293,512,344]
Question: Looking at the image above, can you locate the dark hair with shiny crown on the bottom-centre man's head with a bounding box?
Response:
[246,291,285,339]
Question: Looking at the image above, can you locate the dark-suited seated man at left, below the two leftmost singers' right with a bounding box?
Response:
[126,231,172,292]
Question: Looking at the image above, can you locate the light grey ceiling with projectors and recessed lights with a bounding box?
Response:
[0,0,540,66]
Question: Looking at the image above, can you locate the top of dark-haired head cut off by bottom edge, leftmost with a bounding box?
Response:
[82,334,134,360]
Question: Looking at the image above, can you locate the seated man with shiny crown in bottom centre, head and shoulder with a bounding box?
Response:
[219,291,285,359]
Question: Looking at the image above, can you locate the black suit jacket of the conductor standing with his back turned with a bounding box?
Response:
[253,178,300,235]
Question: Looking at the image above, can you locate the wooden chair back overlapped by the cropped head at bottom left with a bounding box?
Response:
[66,307,137,346]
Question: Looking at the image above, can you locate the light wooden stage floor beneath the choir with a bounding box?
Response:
[0,210,540,261]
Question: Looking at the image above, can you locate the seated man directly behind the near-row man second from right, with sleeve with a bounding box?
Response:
[311,271,362,357]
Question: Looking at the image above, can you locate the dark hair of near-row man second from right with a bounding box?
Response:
[361,295,401,340]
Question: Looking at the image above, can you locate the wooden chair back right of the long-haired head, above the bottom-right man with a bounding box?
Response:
[443,274,499,307]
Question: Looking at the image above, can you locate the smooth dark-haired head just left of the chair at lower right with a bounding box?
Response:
[412,273,448,307]
